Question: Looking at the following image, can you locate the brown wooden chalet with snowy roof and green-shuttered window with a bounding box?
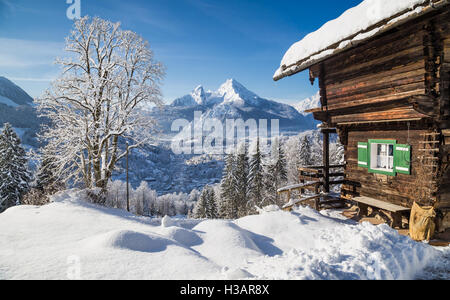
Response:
[274,0,450,231]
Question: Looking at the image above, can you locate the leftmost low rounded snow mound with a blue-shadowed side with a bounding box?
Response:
[82,230,174,252]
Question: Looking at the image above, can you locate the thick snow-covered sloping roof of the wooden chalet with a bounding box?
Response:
[273,0,449,80]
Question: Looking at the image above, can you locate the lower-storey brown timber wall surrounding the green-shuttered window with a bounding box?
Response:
[341,122,437,207]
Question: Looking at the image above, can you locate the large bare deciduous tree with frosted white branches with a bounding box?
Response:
[37,17,164,196]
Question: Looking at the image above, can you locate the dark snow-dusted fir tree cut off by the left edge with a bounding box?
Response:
[0,123,31,212]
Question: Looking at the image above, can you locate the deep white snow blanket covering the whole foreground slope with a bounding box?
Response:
[0,190,442,279]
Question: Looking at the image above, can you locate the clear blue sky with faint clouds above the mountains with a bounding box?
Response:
[0,0,361,103]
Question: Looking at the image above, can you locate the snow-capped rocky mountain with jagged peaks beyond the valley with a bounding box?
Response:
[151,79,317,134]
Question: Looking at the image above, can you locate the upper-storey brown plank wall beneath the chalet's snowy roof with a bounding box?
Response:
[323,24,426,109]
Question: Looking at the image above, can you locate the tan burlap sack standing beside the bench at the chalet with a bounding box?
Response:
[409,202,436,241]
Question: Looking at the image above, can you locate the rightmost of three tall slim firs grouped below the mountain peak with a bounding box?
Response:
[248,138,264,213]
